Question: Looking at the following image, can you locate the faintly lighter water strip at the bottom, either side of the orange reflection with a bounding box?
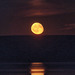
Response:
[0,62,75,75]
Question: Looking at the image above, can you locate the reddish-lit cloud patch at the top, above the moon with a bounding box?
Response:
[17,0,64,17]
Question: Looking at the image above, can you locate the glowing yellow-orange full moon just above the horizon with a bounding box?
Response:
[31,22,44,35]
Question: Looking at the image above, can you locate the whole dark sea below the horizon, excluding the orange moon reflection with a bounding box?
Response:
[0,35,75,75]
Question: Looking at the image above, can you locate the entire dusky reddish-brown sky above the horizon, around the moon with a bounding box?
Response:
[0,0,75,35]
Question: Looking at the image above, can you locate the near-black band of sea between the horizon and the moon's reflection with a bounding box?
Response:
[0,35,75,63]
